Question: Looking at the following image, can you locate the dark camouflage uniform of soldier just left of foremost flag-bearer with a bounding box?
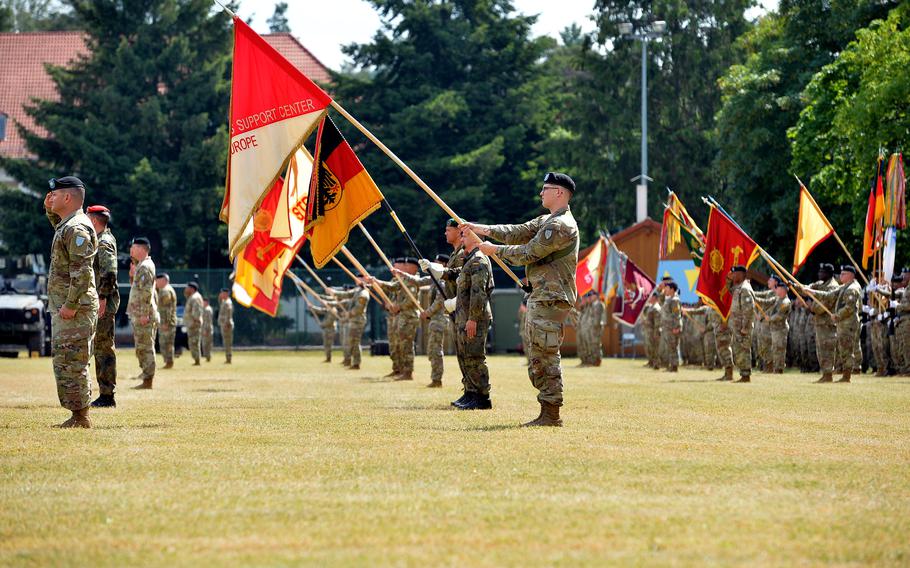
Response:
[455,249,493,395]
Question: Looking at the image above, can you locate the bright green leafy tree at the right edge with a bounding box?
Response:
[789,4,910,260]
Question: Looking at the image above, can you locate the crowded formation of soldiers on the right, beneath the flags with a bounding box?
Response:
[642,263,910,383]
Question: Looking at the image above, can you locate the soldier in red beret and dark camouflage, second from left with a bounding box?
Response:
[85,205,120,407]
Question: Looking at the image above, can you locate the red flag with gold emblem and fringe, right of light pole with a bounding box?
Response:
[695,207,758,321]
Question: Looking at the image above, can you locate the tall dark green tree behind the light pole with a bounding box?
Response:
[548,0,752,242]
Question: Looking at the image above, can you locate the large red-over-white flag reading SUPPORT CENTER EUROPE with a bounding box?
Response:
[221,17,332,257]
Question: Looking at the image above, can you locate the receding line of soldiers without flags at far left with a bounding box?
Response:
[44,176,234,428]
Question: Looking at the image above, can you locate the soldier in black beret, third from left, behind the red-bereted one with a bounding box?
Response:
[126,237,159,389]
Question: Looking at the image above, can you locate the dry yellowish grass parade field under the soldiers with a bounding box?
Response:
[0,350,910,566]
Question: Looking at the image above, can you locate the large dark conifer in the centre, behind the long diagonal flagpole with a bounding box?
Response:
[333,0,555,257]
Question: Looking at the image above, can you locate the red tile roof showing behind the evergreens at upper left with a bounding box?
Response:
[0,32,330,158]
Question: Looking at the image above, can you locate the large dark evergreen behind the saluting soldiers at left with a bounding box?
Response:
[0,0,231,266]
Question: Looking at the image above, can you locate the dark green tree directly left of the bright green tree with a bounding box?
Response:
[716,0,895,259]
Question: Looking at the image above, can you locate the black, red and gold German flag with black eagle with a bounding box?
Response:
[307,117,383,268]
